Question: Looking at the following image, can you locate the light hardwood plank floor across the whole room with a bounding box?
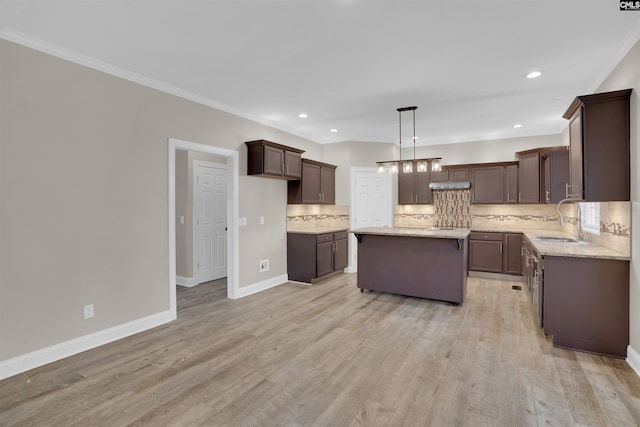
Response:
[0,274,640,426]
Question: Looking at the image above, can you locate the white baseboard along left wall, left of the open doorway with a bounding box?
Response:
[0,311,175,380]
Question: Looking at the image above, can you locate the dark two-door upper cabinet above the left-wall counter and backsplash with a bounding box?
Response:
[288,159,336,205]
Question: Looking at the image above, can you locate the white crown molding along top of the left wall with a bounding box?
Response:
[0,28,318,142]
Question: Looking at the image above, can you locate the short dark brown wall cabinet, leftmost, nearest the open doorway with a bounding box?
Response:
[245,139,304,179]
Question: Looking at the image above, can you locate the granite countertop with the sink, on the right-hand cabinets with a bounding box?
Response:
[522,230,631,261]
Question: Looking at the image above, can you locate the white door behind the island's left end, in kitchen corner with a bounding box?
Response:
[349,168,393,272]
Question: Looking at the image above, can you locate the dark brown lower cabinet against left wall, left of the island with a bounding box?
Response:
[287,231,349,283]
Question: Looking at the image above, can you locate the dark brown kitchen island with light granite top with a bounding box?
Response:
[349,227,469,304]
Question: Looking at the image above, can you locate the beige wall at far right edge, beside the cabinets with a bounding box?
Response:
[596,38,640,353]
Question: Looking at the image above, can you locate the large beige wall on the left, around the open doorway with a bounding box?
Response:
[0,40,320,361]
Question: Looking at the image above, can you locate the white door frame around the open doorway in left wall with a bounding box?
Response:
[168,138,240,319]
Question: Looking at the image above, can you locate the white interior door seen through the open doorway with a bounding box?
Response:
[193,162,227,283]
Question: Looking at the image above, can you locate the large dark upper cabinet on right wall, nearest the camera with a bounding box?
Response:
[562,89,631,202]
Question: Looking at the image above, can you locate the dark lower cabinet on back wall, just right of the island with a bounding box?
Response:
[469,231,522,275]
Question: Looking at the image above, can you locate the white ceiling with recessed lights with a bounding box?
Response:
[0,0,640,145]
